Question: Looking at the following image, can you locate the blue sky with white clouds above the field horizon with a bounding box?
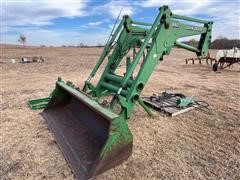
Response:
[0,0,240,46]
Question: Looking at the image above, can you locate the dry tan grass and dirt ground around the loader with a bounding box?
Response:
[0,46,240,180]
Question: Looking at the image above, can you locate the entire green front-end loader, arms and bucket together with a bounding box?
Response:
[28,6,213,179]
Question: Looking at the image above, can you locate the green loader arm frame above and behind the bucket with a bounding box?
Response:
[85,6,213,118]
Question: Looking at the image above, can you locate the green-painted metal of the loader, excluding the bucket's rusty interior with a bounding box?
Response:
[29,6,213,176]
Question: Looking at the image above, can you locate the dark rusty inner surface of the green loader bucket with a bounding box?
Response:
[42,98,109,179]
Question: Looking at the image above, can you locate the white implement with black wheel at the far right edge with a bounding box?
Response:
[212,47,240,71]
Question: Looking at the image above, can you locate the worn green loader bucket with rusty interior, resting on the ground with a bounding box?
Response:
[42,81,133,180]
